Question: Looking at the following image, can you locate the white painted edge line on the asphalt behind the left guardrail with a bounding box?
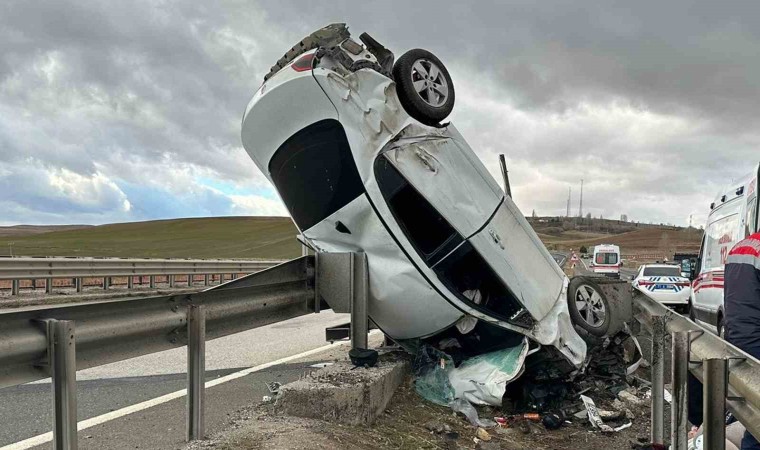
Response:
[0,342,350,450]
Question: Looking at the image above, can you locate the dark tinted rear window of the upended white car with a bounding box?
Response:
[269,119,364,231]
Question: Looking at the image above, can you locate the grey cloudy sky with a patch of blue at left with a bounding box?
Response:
[0,0,760,225]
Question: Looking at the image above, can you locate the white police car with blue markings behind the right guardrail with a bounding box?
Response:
[631,264,691,312]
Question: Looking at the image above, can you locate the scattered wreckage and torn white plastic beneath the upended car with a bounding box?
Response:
[414,331,651,442]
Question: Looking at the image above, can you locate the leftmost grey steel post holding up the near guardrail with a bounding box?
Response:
[45,319,77,450]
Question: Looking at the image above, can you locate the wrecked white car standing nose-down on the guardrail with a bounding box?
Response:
[242,24,586,368]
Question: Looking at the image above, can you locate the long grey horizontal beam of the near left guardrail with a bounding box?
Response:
[0,257,314,388]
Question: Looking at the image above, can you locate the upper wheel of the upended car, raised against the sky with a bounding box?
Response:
[393,48,454,126]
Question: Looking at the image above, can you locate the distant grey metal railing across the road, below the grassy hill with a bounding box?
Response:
[0,257,282,295]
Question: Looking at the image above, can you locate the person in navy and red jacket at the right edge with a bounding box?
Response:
[724,233,760,450]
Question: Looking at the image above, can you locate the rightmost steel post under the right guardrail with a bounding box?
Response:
[702,358,728,450]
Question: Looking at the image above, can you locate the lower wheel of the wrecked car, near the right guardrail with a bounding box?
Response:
[567,277,612,337]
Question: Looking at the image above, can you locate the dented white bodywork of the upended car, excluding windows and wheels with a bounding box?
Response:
[242,47,586,367]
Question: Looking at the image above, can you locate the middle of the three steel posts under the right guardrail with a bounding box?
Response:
[670,331,690,450]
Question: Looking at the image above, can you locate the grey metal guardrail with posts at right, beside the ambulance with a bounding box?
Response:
[634,295,760,450]
